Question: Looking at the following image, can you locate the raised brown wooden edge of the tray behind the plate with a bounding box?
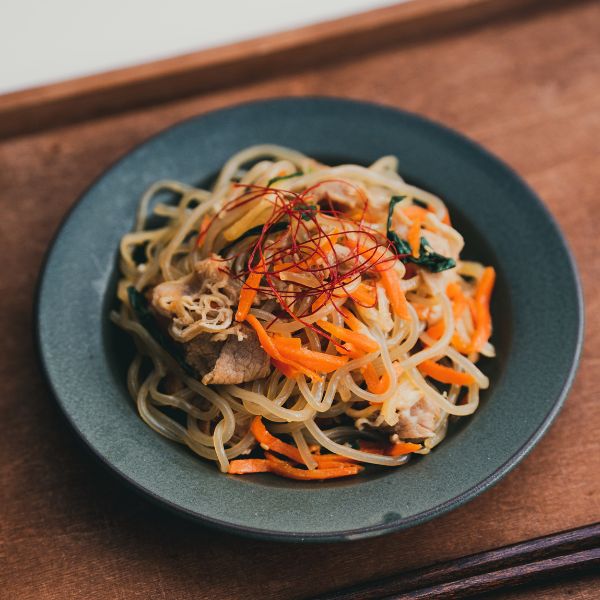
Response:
[0,0,576,137]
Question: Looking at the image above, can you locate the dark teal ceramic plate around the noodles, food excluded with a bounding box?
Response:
[37,98,582,541]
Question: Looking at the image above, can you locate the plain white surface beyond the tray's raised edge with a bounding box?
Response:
[0,0,406,93]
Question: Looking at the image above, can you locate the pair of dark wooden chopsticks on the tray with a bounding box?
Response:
[315,523,600,600]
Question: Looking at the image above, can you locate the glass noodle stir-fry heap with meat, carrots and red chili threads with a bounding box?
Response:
[111,145,495,480]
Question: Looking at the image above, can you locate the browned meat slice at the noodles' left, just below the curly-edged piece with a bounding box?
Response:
[184,325,269,385]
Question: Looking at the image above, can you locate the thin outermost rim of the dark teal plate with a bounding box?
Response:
[32,95,585,543]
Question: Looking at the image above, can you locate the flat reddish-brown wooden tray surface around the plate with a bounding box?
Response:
[0,3,600,600]
